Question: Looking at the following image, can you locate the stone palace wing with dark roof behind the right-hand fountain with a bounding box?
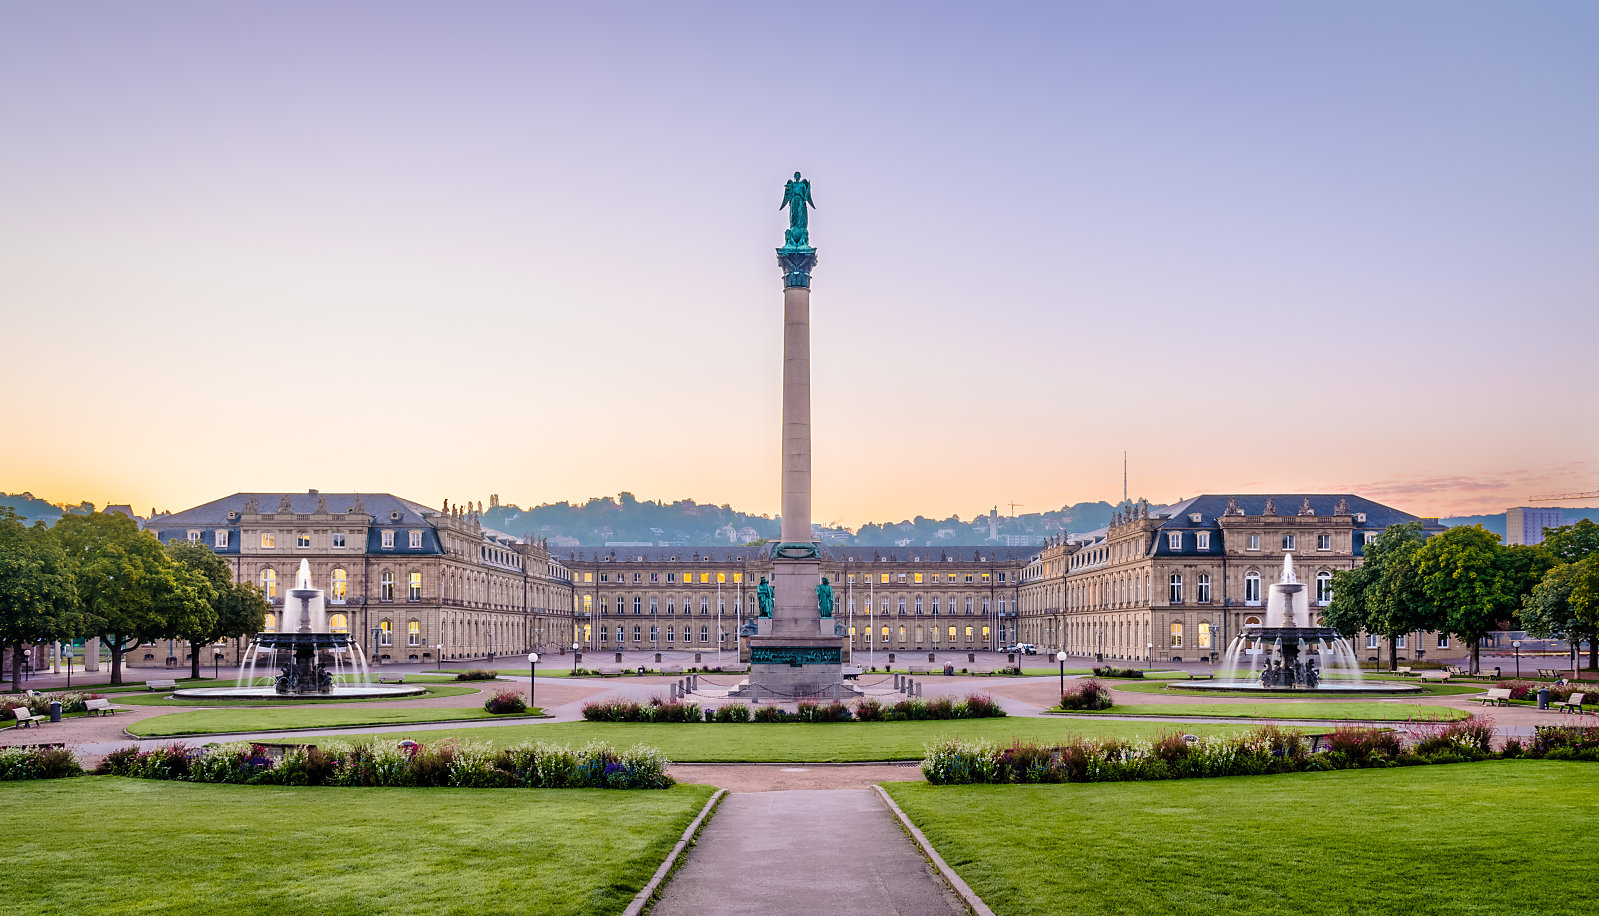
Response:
[1022,494,1468,662]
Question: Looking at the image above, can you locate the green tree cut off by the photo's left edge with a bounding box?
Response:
[0,508,82,691]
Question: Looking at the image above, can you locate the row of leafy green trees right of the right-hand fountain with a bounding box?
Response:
[1322,520,1599,671]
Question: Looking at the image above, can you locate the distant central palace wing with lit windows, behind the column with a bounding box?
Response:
[563,545,1038,663]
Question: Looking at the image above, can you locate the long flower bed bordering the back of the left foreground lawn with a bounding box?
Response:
[98,740,673,788]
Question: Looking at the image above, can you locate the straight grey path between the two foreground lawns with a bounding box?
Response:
[651,788,966,916]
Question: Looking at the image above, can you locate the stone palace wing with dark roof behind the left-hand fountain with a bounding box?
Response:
[140,489,574,665]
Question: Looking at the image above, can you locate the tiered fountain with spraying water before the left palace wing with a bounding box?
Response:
[173,560,427,700]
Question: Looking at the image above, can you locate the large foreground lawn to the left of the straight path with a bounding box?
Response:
[0,777,713,916]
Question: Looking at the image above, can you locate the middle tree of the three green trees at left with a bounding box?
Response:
[51,512,209,684]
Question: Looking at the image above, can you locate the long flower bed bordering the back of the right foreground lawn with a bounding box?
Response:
[921,716,1599,785]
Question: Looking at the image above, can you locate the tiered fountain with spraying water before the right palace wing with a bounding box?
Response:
[1183,553,1420,694]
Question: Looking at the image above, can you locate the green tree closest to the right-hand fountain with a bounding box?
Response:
[1322,521,1441,670]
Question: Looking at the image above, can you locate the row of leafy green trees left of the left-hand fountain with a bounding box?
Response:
[0,508,267,689]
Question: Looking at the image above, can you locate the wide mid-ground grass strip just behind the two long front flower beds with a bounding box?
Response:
[353,716,1298,763]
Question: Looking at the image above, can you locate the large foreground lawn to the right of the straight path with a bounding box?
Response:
[886,761,1599,916]
